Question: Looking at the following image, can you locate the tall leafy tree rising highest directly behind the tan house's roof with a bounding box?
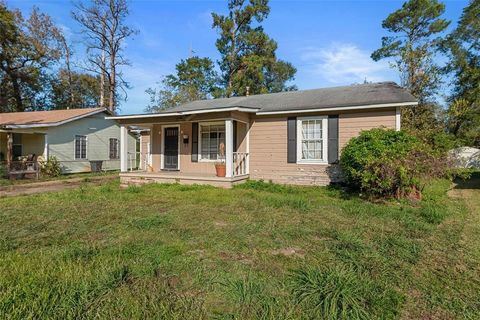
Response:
[212,0,296,97]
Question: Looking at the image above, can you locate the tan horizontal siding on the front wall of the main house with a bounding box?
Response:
[142,108,395,185]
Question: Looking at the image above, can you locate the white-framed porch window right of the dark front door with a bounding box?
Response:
[199,123,225,160]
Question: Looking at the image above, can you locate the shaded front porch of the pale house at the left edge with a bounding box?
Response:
[0,130,48,179]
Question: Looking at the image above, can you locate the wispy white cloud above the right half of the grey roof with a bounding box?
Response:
[300,43,394,84]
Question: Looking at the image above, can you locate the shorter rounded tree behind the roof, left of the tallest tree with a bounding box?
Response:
[146,56,219,112]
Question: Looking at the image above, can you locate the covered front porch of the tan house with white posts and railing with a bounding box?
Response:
[116,112,250,188]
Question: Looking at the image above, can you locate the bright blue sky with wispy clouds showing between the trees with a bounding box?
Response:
[7,0,468,114]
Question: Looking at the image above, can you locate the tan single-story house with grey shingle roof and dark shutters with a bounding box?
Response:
[107,82,417,187]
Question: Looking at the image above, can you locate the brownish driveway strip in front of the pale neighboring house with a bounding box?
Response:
[0,175,118,197]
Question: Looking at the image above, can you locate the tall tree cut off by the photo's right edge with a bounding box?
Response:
[442,0,480,145]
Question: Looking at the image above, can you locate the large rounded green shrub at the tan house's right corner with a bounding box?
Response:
[340,129,448,198]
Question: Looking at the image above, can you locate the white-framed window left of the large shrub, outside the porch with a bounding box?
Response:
[297,117,327,163]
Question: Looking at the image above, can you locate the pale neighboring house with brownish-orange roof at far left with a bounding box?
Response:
[0,108,136,173]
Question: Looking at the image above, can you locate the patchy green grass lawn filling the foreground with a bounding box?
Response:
[0,177,480,319]
